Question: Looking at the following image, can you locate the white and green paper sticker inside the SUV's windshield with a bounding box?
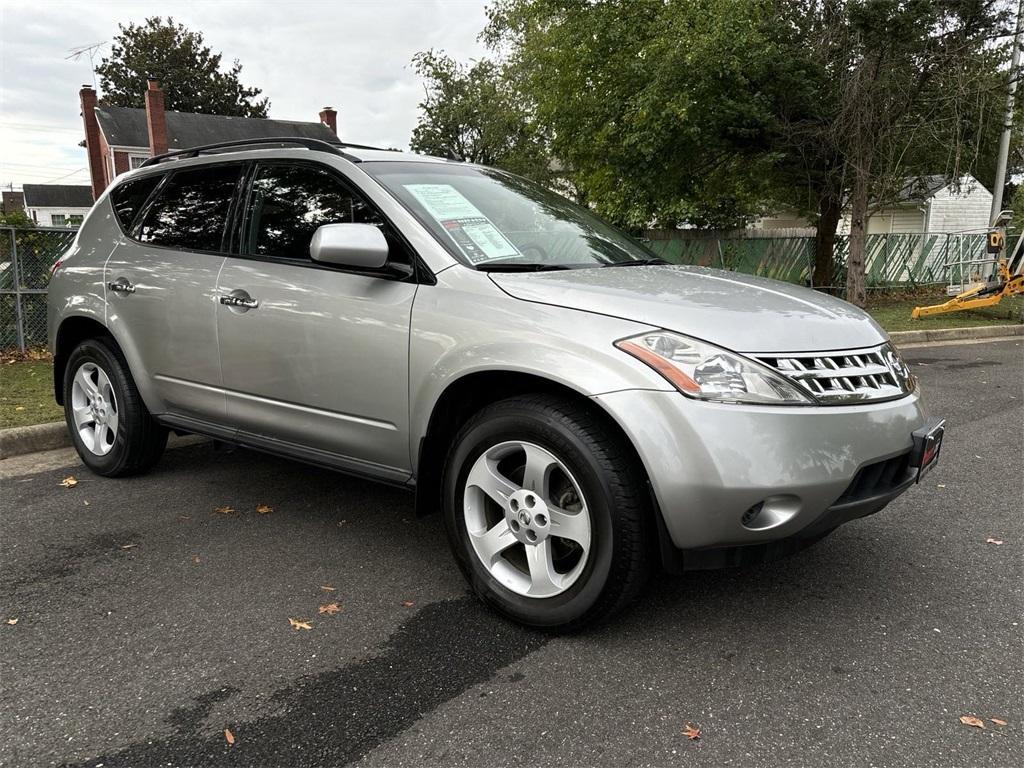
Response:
[406,184,519,264]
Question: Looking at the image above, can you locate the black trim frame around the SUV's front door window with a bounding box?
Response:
[228,158,437,286]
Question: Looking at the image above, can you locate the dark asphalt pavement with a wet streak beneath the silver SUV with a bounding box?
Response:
[0,341,1024,768]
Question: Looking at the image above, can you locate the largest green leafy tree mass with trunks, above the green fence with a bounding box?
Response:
[484,0,1007,304]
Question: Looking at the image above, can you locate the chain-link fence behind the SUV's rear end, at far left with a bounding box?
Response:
[0,226,76,352]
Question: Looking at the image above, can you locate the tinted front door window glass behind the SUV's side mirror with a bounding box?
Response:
[247,165,383,259]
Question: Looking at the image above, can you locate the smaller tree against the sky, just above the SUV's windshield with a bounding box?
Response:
[410,50,554,183]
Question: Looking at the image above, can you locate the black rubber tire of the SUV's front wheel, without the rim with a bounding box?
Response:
[443,394,654,632]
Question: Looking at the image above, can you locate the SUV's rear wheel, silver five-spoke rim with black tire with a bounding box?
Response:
[63,339,167,477]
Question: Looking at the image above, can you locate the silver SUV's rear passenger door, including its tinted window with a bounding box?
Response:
[104,163,244,424]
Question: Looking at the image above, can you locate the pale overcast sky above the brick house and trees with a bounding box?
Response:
[0,0,486,188]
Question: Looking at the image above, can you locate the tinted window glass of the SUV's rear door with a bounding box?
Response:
[137,165,242,251]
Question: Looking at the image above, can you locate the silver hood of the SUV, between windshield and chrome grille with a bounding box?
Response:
[490,265,888,352]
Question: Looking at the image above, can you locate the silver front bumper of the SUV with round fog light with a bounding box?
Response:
[594,390,925,551]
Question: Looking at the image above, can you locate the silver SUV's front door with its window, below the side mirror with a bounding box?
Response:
[217,161,417,479]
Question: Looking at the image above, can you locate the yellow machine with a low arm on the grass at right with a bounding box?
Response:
[910,211,1024,319]
